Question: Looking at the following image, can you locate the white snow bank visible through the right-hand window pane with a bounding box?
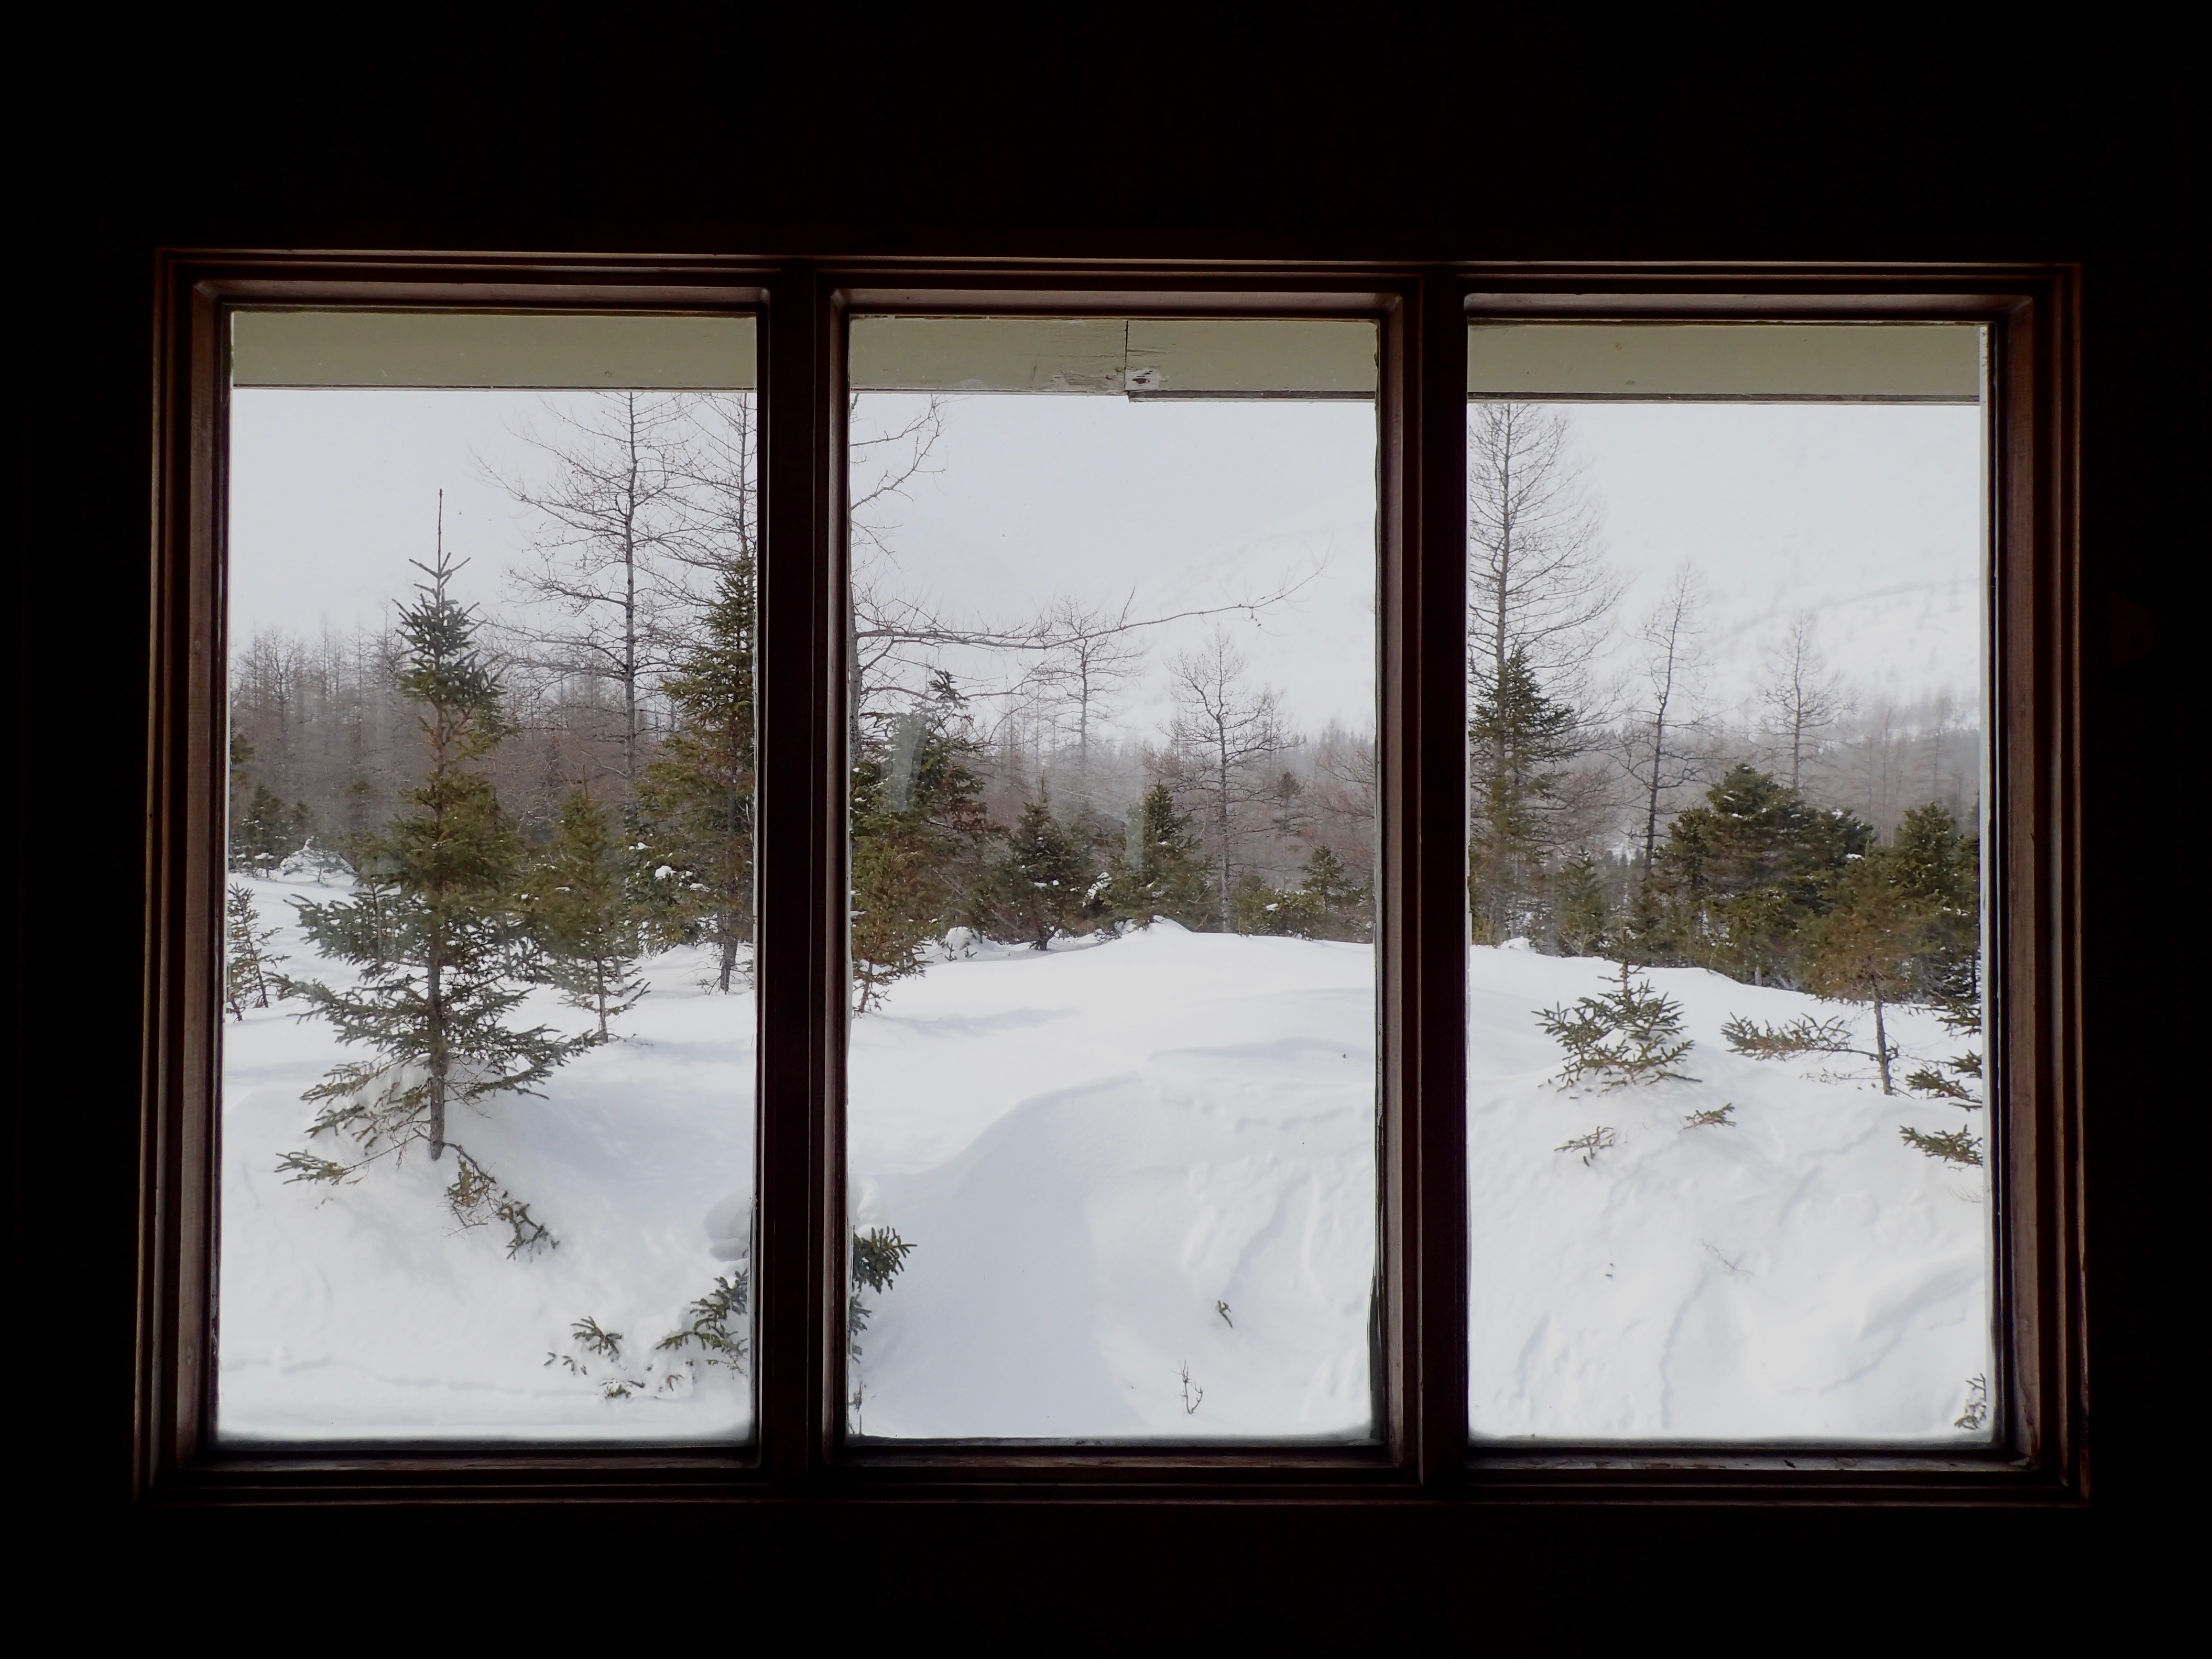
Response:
[1467,949,1991,1442]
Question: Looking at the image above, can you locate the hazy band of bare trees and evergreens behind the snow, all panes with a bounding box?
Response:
[230,394,1982,1009]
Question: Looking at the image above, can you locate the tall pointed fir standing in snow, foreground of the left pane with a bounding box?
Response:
[281,526,600,1185]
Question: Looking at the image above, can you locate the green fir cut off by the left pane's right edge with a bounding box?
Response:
[635,560,757,991]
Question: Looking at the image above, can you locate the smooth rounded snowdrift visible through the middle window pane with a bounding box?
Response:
[849,922,1376,1440]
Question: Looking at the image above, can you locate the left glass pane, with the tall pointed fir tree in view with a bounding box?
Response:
[217,312,754,1440]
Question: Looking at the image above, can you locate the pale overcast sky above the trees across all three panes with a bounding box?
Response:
[230,389,1980,734]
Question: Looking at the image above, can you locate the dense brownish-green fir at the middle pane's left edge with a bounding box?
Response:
[849,675,991,1013]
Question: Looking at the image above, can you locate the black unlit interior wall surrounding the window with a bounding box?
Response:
[0,4,2205,1648]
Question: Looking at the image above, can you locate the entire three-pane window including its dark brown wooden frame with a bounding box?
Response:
[134,261,2079,1500]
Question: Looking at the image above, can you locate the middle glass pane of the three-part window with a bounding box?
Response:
[847,319,1376,1440]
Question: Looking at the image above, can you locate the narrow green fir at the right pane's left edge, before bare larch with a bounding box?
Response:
[1467,648,1582,945]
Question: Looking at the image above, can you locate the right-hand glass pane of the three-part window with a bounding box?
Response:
[1467,325,1993,1442]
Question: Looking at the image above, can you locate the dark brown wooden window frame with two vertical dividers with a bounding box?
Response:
[135,252,2086,1504]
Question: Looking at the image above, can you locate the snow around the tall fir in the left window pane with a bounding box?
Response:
[217,876,752,1440]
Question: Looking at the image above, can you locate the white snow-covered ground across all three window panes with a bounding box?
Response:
[219,880,1989,1440]
